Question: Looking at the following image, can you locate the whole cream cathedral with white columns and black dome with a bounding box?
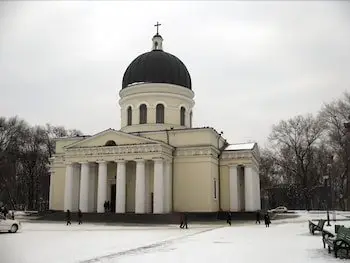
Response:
[50,26,260,214]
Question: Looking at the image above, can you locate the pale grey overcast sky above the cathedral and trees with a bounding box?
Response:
[0,1,350,147]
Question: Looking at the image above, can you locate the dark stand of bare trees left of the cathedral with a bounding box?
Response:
[0,117,81,209]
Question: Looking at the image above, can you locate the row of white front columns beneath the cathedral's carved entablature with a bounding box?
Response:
[64,158,172,214]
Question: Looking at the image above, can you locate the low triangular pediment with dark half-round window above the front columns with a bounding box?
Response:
[65,129,159,149]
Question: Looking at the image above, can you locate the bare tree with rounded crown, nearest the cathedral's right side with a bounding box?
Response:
[269,114,325,209]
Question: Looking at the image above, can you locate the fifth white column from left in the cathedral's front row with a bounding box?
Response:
[135,159,146,214]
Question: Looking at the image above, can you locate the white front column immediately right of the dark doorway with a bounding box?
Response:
[115,161,126,213]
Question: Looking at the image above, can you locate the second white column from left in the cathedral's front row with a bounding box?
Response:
[79,162,90,213]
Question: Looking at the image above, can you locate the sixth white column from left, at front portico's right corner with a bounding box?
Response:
[153,159,164,214]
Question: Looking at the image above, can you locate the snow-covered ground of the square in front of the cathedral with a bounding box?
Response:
[0,212,350,263]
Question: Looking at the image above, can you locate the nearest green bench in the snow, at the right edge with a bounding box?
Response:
[324,227,350,258]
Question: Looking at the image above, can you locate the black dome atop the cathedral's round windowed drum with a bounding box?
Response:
[122,50,192,89]
